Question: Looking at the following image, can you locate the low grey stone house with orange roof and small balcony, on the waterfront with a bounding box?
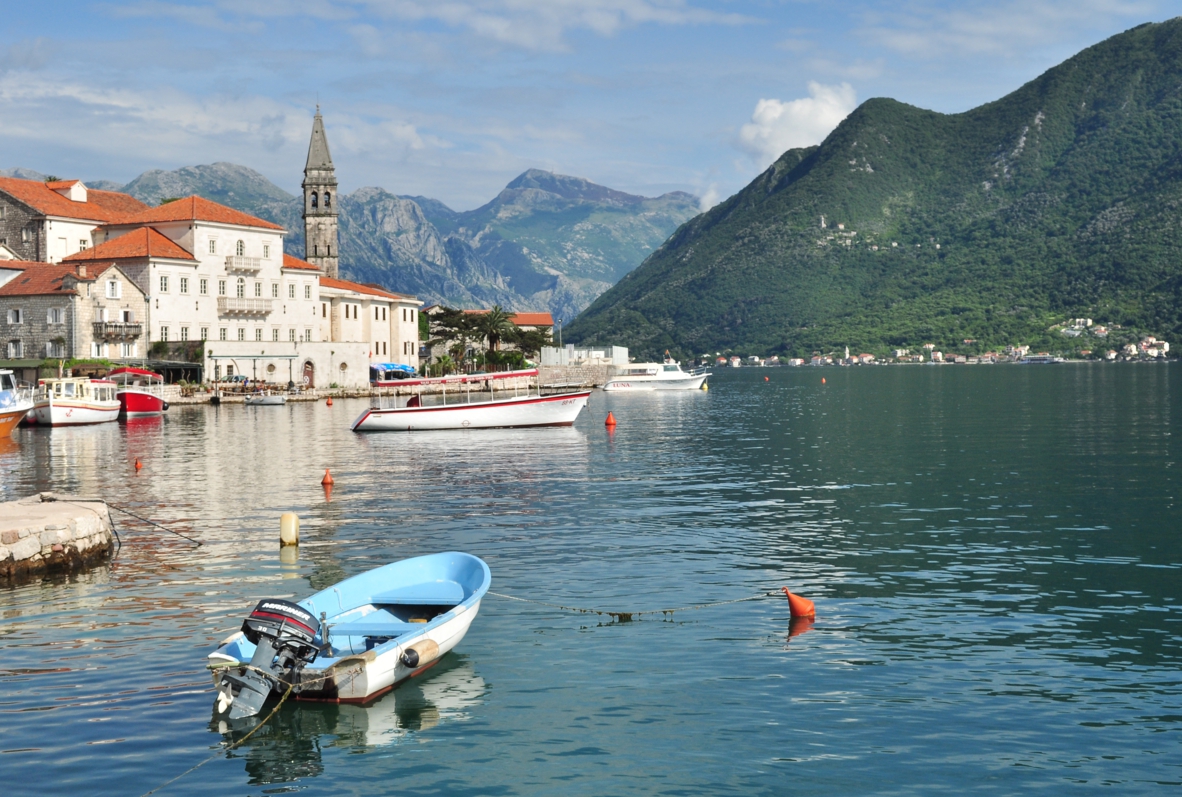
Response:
[0,261,148,359]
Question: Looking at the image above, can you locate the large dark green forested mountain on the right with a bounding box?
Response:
[565,18,1182,356]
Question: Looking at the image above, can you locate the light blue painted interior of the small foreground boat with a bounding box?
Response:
[217,551,492,672]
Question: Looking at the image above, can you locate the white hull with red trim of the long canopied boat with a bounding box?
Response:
[352,390,591,432]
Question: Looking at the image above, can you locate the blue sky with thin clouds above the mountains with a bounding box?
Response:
[0,0,1180,209]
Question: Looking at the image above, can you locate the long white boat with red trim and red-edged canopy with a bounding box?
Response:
[352,369,591,432]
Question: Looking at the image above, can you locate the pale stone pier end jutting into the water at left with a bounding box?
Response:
[0,493,115,582]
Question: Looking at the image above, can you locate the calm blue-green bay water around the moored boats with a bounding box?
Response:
[0,365,1182,795]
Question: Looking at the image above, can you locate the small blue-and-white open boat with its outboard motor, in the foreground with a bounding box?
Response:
[208,551,492,719]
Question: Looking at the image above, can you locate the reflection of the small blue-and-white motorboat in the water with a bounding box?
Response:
[209,654,485,785]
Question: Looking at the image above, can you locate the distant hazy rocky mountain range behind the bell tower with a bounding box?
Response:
[69,163,697,319]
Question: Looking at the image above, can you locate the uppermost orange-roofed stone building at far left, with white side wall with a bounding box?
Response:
[0,177,148,263]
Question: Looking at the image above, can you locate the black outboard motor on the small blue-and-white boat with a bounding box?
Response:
[219,598,320,719]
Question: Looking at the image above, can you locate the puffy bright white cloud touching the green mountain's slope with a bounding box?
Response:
[739,80,858,168]
